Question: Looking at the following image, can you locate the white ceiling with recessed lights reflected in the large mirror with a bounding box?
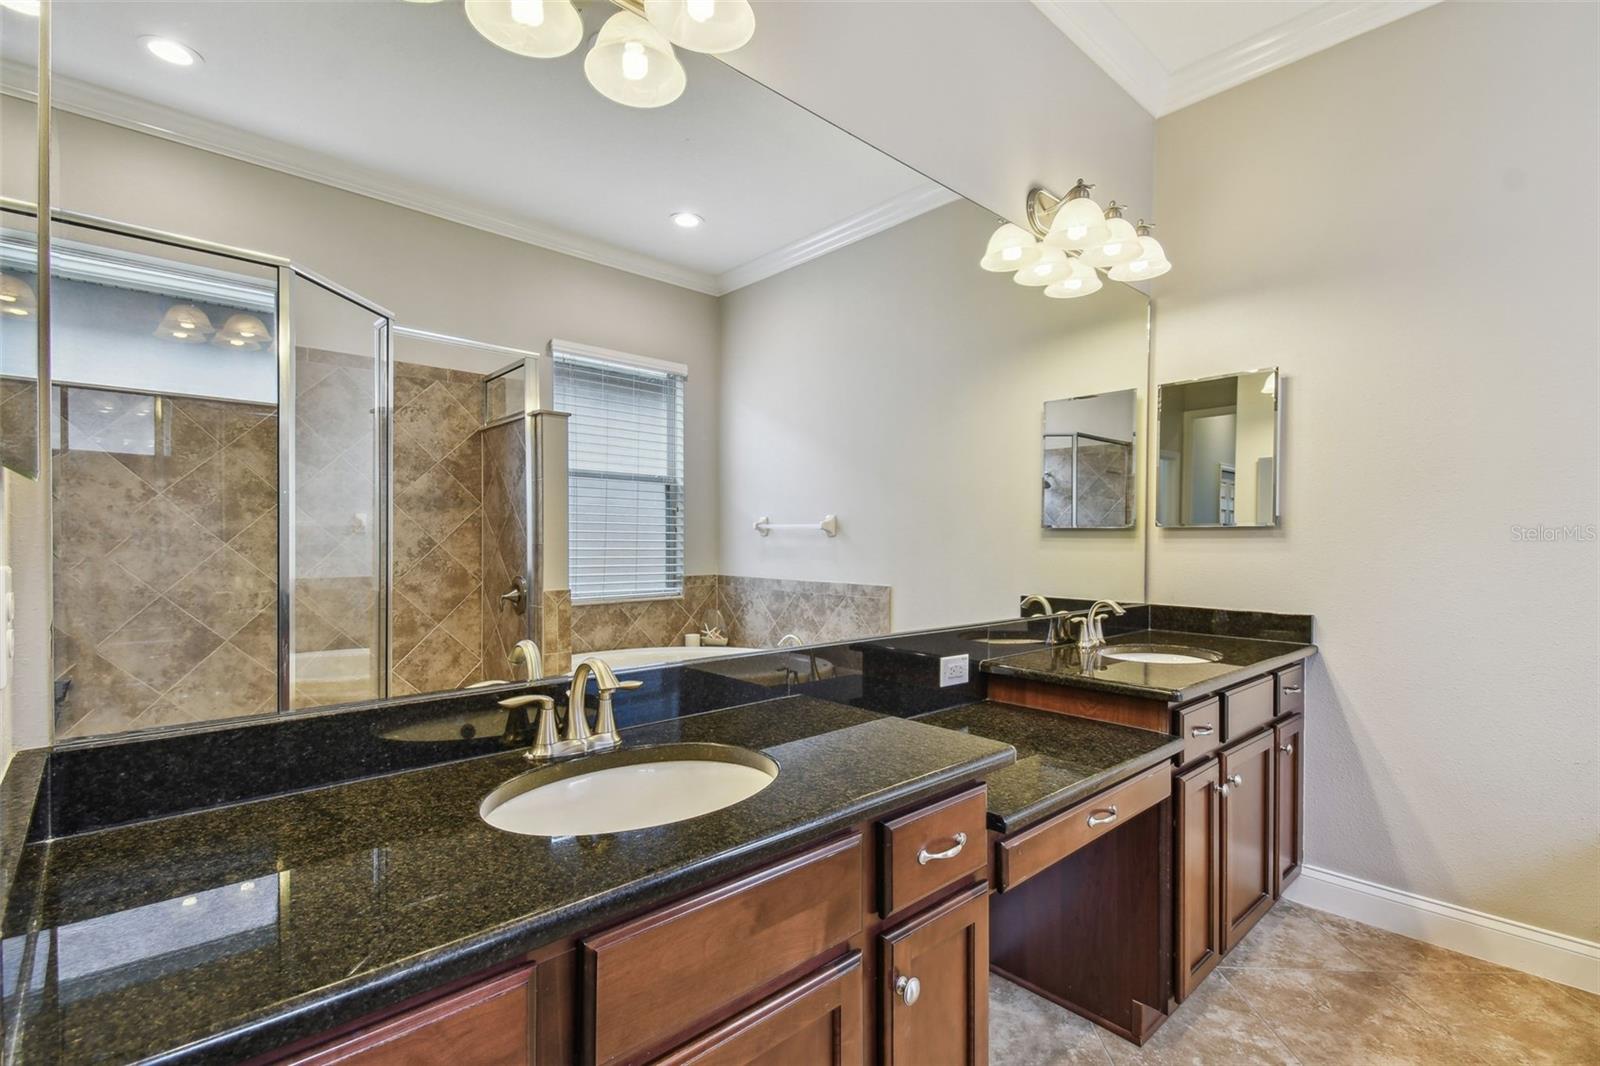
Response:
[12,0,955,293]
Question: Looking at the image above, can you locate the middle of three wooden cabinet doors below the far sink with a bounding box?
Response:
[1221,730,1277,952]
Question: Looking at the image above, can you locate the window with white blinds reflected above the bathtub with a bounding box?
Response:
[554,349,683,603]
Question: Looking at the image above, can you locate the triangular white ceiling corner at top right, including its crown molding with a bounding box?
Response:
[1034,0,1438,117]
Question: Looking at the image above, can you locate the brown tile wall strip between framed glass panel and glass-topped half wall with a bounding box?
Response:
[389,363,485,696]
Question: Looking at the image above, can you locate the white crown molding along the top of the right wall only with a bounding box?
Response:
[1162,0,1438,114]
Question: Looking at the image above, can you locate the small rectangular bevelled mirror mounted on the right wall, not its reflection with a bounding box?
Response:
[1155,367,1283,528]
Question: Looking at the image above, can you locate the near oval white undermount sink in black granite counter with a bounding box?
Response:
[478,744,778,837]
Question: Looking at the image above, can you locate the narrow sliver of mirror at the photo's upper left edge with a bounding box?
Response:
[0,5,43,477]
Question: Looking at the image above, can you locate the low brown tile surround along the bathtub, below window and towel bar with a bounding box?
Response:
[560,575,890,656]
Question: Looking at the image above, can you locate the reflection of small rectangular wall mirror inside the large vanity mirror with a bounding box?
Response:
[1043,389,1139,530]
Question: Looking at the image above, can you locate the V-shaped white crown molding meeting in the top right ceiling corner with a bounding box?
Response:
[1034,0,1438,118]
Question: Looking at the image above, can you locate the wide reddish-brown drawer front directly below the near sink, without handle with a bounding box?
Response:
[582,832,866,1064]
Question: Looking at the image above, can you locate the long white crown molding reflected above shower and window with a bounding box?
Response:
[18,70,718,296]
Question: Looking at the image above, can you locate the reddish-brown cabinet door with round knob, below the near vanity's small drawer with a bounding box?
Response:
[878,885,989,1066]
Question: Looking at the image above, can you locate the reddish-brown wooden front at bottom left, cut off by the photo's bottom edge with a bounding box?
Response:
[282,967,533,1066]
